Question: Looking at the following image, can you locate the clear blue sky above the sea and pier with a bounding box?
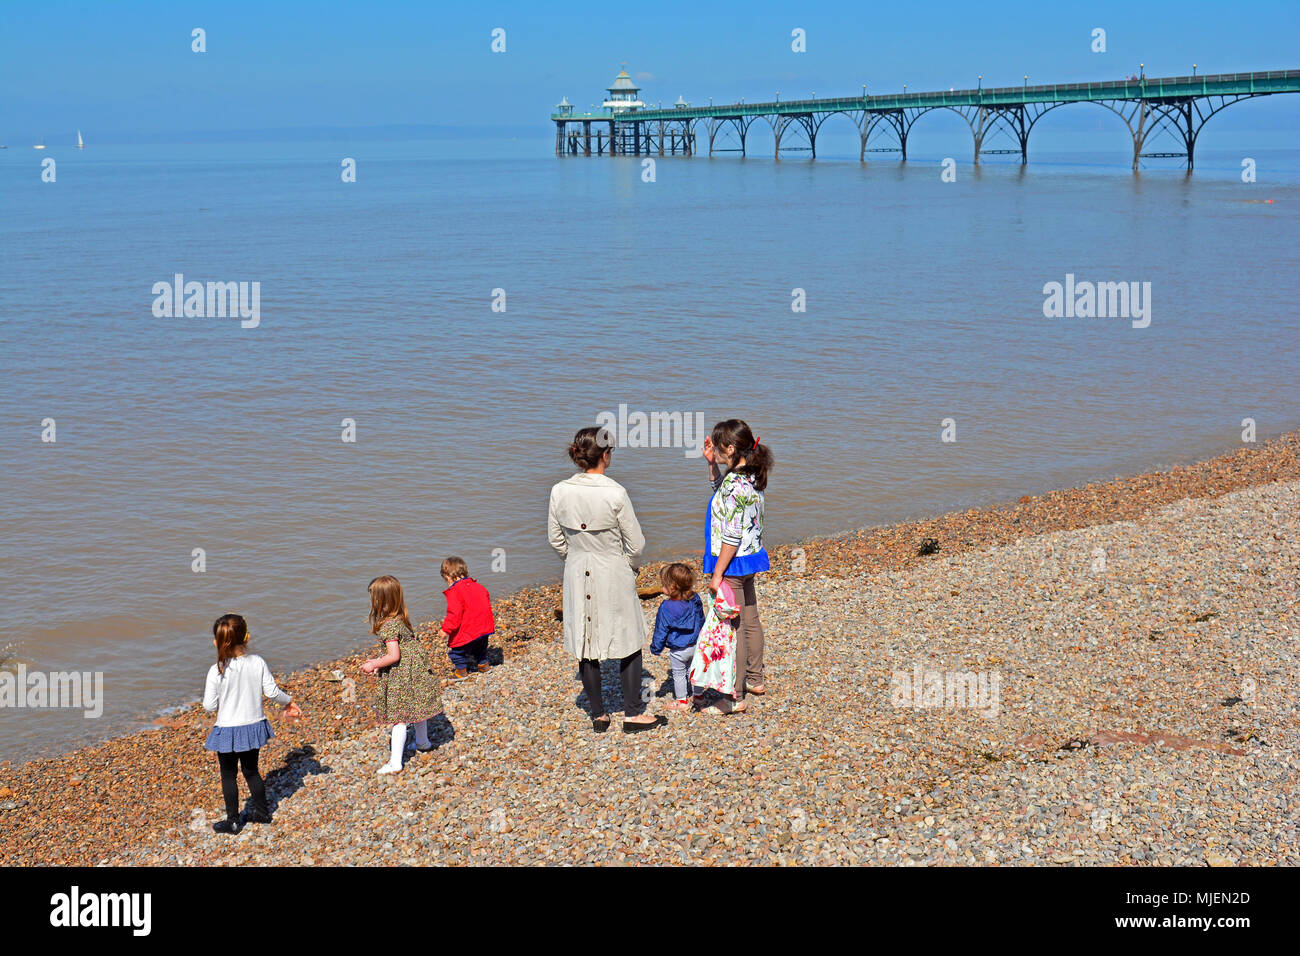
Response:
[0,0,1300,144]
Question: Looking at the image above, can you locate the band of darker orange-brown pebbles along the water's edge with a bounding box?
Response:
[0,432,1300,865]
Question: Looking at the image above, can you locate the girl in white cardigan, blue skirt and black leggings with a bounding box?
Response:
[203,614,303,834]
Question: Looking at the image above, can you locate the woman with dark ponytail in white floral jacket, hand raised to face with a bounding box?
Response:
[705,419,772,713]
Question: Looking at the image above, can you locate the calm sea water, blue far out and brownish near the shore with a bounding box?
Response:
[0,138,1300,758]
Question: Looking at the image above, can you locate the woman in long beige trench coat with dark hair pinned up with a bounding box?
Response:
[546,428,667,734]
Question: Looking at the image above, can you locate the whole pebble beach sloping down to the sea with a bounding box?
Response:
[0,432,1300,866]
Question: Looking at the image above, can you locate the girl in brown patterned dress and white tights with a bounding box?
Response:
[361,575,442,774]
